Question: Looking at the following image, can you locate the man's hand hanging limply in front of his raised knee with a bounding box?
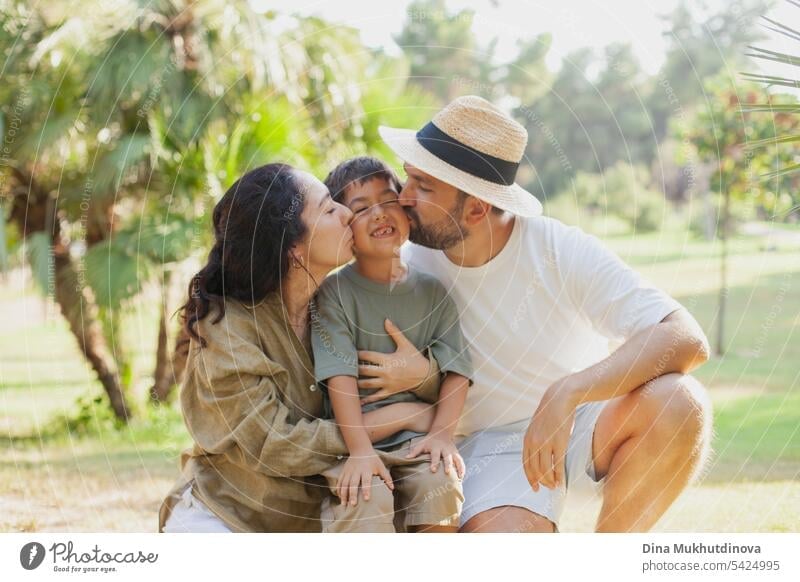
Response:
[522,382,576,491]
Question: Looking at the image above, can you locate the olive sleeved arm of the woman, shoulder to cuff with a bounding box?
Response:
[186,320,347,477]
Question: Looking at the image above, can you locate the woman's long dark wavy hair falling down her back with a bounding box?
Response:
[179,164,306,347]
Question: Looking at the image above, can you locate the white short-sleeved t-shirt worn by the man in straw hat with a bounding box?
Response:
[402,216,681,436]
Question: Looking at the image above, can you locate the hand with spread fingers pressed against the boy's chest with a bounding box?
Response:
[358,319,431,406]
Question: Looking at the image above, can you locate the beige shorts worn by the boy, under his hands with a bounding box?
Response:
[320,436,464,533]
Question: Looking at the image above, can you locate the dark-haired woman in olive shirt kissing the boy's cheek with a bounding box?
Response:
[159,164,438,532]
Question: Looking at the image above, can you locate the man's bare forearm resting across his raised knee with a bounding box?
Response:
[560,309,710,407]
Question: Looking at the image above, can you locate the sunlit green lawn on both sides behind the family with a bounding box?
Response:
[0,227,800,531]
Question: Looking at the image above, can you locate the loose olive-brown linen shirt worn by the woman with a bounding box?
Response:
[158,292,440,532]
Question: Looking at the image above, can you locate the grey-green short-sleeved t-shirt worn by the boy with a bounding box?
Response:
[311,263,472,449]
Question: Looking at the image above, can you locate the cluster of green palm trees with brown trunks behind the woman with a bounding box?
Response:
[0,0,424,421]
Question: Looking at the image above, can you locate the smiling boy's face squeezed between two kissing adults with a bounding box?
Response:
[342,178,409,259]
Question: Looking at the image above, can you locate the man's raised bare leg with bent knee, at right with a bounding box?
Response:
[593,374,712,532]
